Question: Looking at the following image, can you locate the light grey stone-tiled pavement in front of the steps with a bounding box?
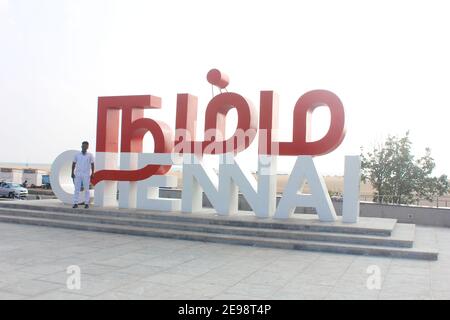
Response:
[0,224,450,300]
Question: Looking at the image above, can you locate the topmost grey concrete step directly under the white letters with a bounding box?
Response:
[0,200,397,236]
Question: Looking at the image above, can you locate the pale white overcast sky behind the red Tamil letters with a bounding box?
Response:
[0,0,450,174]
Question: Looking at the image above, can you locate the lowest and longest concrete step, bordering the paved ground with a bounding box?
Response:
[0,215,438,260]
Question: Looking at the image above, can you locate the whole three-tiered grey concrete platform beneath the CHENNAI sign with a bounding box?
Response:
[0,200,438,260]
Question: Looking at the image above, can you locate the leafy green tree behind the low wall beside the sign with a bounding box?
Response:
[361,132,449,204]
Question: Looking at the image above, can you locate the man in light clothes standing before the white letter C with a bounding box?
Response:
[72,141,94,209]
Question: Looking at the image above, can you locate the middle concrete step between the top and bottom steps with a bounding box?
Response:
[0,208,415,248]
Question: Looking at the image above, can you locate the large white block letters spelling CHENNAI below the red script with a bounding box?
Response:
[50,151,361,223]
